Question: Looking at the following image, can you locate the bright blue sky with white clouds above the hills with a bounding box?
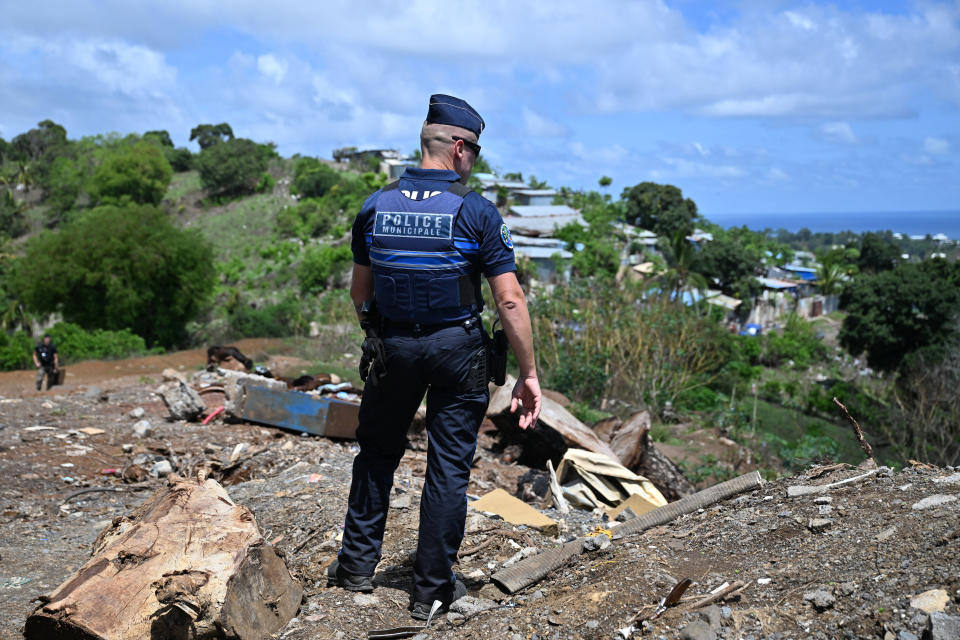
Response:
[0,0,960,217]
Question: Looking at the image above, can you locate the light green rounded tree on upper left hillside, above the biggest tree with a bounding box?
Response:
[90,142,173,204]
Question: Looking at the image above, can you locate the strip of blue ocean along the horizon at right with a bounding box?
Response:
[701,211,960,240]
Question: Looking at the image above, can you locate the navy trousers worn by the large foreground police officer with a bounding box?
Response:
[339,321,490,602]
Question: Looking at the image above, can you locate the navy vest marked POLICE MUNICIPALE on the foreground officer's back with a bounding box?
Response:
[370,182,482,325]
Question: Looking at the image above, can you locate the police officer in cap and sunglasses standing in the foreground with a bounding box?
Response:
[328,94,541,620]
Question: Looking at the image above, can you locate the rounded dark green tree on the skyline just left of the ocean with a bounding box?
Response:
[621,182,698,238]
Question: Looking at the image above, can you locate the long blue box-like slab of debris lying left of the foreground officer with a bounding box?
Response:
[240,386,360,439]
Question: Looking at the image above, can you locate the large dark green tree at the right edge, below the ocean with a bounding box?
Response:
[839,259,960,371]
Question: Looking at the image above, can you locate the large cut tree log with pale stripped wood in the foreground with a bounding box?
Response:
[24,476,303,640]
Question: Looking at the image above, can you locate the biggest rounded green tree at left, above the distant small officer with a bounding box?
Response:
[13,204,215,347]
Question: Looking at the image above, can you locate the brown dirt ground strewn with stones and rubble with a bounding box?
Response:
[0,350,960,640]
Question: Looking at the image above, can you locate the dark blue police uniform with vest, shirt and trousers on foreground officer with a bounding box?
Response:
[340,169,516,603]
